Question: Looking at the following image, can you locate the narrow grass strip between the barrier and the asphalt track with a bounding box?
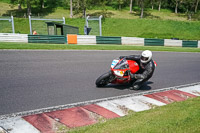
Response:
[0,42,200,52]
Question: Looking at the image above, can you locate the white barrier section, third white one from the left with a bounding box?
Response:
[122,37,144,46]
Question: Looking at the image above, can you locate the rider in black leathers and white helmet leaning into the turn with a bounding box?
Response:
[119,50,155,90]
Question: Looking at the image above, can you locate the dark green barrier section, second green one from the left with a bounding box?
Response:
[96,36,122,45]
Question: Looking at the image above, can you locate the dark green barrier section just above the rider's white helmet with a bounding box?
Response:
[144,38,164,46]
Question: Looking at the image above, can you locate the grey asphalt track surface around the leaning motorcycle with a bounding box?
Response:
[0,50,200,115]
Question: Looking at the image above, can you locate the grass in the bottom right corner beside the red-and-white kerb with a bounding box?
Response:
[67,97,200,133]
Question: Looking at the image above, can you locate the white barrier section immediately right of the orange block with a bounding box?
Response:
[77,35,96,45]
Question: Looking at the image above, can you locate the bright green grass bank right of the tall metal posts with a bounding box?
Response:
[102,18,200,40]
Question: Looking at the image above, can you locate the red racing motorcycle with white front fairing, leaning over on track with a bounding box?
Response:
[96,58,157,87]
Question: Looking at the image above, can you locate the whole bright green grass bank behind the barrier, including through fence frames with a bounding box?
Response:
[0,18,200,40]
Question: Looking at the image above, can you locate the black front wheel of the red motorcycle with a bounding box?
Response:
[96,72,111,87]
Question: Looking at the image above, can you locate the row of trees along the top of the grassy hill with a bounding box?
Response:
[10,0,200,19]
